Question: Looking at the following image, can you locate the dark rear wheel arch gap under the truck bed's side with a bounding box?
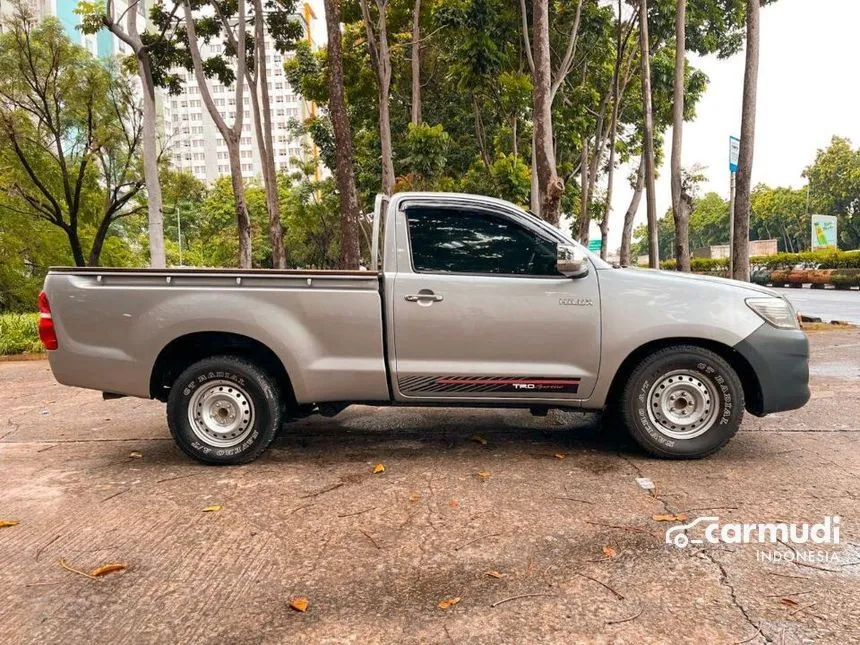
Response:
[149,331,296,408]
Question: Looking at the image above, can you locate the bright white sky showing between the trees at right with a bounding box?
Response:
[311,0,860,250]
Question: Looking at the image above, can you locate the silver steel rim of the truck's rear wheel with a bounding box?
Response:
[188,380,254,448]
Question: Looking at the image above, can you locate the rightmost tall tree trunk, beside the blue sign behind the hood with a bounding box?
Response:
[732,0,760,282]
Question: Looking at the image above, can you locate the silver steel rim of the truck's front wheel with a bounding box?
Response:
[648,370,719,439]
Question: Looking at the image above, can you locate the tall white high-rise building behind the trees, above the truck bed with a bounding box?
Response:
[163,11,313,183]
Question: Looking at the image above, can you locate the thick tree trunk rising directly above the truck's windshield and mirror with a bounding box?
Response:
[532,0,564,226]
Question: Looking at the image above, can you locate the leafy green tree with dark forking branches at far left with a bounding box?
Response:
[0,9,143,266]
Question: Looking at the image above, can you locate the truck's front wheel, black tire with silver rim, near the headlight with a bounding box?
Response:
[619,345,744,459]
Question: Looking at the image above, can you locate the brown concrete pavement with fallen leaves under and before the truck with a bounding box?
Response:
[0,331,860,645]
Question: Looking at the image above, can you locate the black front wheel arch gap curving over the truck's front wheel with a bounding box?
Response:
[606,336,763,415]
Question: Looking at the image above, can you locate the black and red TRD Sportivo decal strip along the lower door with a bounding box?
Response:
[398,376,580,394]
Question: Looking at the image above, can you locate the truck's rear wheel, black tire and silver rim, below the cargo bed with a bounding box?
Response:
[167,356,282,465]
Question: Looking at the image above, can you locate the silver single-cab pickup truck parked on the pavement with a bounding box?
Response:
[40,193,809,464]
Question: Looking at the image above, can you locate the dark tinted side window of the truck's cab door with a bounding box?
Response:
[406,206,559,276]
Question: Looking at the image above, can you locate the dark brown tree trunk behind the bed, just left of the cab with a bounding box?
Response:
[324,0,362,271]
